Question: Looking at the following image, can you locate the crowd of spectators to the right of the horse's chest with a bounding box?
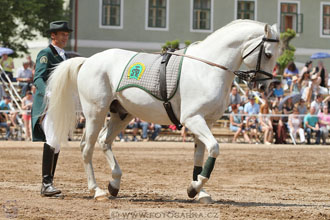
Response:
[228,61,330,144]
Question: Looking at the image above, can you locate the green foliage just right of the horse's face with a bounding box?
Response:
[277,29,296,73]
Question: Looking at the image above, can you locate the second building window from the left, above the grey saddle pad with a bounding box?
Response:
[148,0,167,28]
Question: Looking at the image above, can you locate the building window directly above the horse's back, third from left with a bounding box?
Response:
[192,0,211,30]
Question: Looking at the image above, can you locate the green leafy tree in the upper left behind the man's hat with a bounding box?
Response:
[0,0,68,56]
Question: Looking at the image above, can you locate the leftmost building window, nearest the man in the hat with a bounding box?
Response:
[102,0,122,26]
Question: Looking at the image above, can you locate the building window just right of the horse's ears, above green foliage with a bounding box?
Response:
[280,2,303,33]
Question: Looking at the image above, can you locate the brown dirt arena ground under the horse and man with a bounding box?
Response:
[0,141,330,220]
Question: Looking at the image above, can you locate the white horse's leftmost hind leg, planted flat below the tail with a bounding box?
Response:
[80,106,107,199]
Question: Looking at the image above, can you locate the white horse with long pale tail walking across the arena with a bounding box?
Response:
[47,20,279,202]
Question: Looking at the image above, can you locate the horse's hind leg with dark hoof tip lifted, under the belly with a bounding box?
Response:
[98,113,133,196]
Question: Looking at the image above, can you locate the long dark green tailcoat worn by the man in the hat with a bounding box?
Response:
[31,45,63,142]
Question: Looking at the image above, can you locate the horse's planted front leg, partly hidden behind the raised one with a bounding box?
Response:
[193,138,212,203]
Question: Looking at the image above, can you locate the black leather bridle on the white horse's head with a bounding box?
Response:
[234,37,279,82]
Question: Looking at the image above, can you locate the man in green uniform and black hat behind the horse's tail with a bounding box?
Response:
[32,21,72,196]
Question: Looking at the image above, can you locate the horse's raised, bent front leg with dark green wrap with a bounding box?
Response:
[185,115,219,198]
